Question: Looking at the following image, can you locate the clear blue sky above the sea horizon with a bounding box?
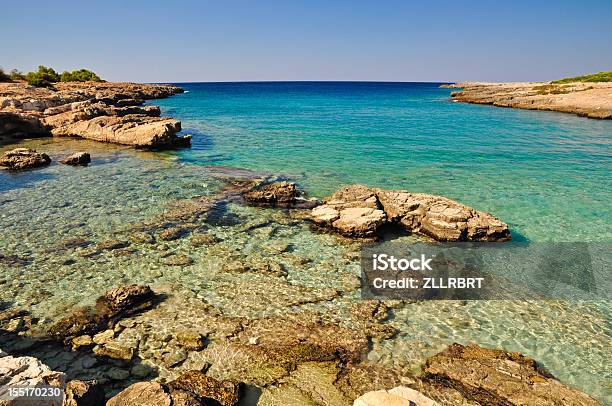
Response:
[0,0,612,82]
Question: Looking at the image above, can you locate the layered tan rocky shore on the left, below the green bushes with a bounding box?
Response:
[0,82,190,148]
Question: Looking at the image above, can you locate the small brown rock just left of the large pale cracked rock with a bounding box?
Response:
[242,181,316,208]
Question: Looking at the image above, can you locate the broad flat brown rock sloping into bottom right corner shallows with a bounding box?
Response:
[424,344,599,406]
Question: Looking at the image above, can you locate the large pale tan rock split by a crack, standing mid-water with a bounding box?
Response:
[311,185,511,241]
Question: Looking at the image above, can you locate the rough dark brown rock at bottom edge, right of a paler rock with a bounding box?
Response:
[168,371,238,406]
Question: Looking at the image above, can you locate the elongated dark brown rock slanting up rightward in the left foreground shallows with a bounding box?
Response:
[47,285,155,341]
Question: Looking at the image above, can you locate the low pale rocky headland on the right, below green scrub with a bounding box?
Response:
[441,82,612,120]
